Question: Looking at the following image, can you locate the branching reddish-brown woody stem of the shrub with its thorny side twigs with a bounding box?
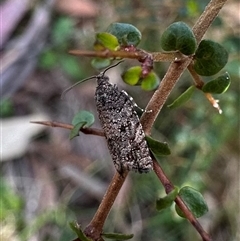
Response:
[34,0,227,241]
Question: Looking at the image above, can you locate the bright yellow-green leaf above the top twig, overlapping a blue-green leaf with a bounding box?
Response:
[95,32,119,50]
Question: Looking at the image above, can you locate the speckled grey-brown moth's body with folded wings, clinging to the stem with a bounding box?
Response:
[95,74,153,174]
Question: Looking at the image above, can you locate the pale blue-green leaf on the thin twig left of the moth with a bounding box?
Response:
[70,110,94,140]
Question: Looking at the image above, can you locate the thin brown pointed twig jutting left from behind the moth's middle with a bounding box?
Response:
[30,121,104,136]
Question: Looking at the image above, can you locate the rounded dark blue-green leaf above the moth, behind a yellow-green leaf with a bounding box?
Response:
[107,23,142,46]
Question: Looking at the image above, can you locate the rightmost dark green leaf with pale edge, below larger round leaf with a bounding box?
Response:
[202,73,231,94]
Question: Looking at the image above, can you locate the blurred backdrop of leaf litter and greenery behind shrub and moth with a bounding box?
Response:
[0,0,240,241]
